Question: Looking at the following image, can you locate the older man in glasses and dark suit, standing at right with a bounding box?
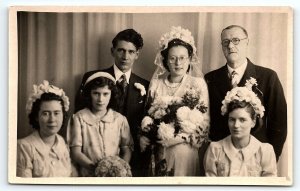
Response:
[205,25,287,161]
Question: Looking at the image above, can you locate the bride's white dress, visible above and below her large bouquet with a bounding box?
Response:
[149,75,209,176]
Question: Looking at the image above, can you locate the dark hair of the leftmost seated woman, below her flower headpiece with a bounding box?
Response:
[28,93,68,130]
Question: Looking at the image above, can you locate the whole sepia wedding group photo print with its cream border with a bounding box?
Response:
[8,7,293,185]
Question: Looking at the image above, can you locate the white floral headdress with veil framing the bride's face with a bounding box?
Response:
[154,26,202,76]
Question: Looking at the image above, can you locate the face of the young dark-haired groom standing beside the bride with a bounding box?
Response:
[111,40,139,73]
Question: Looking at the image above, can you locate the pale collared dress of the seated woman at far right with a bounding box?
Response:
[204,135,277,176]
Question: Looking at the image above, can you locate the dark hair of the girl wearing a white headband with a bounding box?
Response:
[83,77,120,111]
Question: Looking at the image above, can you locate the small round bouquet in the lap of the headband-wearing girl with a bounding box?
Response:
[95,156,132,177]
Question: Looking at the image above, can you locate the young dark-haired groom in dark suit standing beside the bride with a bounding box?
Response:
[75,29,149,176]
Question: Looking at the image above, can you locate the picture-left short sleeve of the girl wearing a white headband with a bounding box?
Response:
[67,114,82,147]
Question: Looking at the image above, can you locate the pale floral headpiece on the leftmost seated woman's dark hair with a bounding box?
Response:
[26,80,70,114]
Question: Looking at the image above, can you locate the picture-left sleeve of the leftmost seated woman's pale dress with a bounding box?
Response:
[17,141,33,177]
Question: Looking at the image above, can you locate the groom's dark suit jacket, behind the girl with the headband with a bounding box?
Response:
[75,67,149,176]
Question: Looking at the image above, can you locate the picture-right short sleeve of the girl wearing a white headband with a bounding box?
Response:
[120,116,134,151]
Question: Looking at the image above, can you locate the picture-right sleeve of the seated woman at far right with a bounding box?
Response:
[261,143,277,176]
